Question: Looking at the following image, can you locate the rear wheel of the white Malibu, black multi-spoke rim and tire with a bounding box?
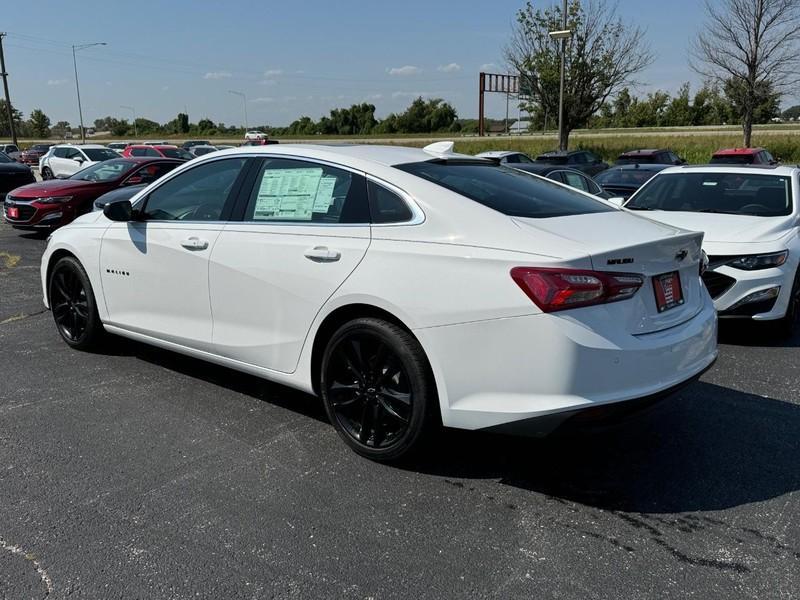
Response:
[320,317,437,462]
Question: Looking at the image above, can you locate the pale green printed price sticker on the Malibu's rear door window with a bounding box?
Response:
[253,168,322,221]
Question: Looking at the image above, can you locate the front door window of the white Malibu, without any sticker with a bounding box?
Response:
[140,158,247,221]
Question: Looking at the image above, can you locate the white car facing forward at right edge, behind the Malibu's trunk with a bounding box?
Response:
[625,165,800,335]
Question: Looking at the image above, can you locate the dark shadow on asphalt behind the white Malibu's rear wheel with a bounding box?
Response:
[405,383,800,513]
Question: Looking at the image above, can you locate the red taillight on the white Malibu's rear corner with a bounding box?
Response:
[511,267,644,312]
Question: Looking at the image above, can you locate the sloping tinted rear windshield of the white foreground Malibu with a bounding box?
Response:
[397,161,615,219]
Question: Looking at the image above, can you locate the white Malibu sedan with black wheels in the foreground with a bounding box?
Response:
[41,142,717,460]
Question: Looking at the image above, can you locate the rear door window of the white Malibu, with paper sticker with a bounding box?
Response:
[244,158,370,224]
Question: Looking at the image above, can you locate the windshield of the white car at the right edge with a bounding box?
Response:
[625,173,792,217]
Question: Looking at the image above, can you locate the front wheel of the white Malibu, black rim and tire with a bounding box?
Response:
[47,256,105,351]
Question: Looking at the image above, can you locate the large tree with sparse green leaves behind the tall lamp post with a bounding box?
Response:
[505,0,652,149]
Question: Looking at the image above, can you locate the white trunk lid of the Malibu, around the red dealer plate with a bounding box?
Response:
[514,211,707,335]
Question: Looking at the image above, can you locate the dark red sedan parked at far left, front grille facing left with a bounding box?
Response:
[3,158,184,229]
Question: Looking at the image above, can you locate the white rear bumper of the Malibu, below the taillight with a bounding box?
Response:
[415,294,717,433]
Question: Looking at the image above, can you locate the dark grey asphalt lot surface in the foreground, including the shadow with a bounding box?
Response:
[0,220,800,599]
